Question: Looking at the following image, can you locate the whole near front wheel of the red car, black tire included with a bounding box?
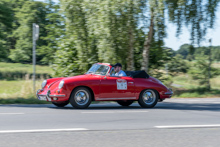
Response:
[70,87,92,109]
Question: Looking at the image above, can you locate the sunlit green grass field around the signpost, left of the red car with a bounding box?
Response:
[0,62,53,104]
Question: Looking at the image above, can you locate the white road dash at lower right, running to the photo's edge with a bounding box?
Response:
[154,124,220,129]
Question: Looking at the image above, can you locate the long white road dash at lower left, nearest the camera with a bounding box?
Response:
[0,128,88,133]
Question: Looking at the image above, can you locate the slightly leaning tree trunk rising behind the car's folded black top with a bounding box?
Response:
[141,10,154,72]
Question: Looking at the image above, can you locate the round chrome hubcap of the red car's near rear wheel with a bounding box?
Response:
[142,90,156,105]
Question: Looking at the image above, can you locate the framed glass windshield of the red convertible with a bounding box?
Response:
[86,64,109,75]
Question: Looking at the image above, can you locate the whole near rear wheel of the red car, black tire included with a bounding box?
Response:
[138,89,159,108]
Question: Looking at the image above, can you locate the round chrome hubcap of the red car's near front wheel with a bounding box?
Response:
[75,90,89,105]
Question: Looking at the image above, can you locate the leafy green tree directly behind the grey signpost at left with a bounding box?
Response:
[9,0,63,64]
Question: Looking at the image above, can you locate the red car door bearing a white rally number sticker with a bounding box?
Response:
[99,76,135,100]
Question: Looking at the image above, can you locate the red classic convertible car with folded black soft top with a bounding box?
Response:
[36,63,173,109]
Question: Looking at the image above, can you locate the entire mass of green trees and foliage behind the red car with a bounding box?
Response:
[0,0,220,76]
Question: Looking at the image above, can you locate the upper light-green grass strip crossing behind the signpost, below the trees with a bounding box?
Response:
[0,62,53,74]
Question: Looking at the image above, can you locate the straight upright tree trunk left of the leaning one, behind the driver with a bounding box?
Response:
[127,28,134,71]
